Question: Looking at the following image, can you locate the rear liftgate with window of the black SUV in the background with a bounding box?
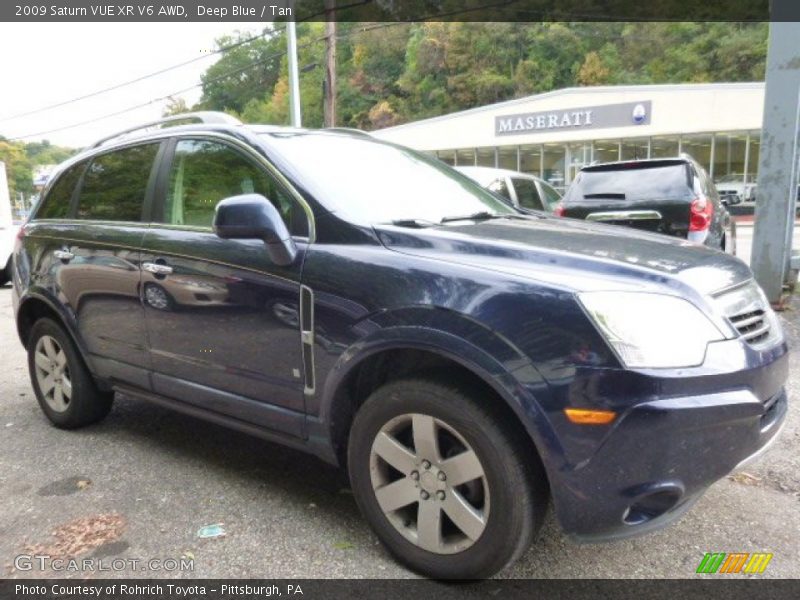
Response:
[562,162,693,238]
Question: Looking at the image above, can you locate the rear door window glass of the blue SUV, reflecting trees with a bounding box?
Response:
[78,143,158,221]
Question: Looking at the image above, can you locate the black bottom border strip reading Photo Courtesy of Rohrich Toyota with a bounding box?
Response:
[0,576,800,600]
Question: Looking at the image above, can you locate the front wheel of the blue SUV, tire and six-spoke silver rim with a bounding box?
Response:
[348,379,548,579]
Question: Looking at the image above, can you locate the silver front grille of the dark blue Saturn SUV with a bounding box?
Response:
[715,281,782,348]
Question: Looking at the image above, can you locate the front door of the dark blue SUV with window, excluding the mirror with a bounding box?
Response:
[142,138,308,435]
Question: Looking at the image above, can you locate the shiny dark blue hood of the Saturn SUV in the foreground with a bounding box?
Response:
[376,216,752,294]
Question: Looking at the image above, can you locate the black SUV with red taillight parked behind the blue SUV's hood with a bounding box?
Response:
[556,155,736,254]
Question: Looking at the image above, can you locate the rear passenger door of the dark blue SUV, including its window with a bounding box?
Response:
[49,142,163,389]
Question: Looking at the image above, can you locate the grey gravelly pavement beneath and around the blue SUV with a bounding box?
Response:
[0,286,800,578]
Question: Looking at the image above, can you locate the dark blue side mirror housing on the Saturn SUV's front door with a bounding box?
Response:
[214,194,297,267]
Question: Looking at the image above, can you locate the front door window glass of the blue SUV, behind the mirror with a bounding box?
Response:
[163,140,308,236]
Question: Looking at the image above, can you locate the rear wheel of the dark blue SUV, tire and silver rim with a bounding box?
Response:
[28,318,114,429]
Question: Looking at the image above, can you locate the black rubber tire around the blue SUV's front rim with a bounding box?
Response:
[348,377,549,580]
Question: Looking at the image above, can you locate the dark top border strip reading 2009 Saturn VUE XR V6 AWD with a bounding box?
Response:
[0,0,800,22]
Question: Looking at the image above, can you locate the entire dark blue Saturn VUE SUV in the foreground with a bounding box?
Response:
[13,114,788,578]
